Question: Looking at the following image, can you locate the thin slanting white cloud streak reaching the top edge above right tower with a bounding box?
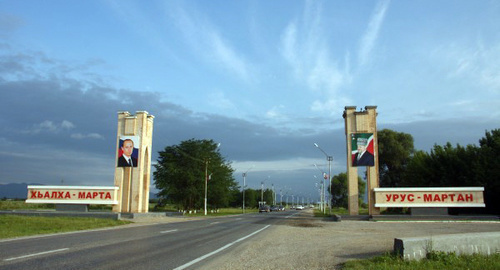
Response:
[358,0,390,66]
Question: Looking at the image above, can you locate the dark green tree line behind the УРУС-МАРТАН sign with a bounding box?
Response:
[378,129,500,214]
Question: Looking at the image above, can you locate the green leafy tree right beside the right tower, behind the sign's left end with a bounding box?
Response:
[377,129,415,187]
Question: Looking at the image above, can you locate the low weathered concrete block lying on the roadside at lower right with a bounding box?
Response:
[394,232,500,260]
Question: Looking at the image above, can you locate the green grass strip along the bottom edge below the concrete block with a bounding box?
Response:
[342,252,500,270]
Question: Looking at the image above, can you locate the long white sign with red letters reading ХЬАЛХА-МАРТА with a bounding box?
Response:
[26,186,118,205]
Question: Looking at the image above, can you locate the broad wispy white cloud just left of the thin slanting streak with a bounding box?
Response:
[281,2,352,112]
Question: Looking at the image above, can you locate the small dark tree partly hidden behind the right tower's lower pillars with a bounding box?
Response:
[328,173,366,208]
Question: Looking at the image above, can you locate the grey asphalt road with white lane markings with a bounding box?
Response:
[0,211,298,270]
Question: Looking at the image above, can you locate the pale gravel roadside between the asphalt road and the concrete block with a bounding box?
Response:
[197,210,500,270]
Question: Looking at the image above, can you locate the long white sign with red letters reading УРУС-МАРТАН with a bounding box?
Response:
[374,187,485,207]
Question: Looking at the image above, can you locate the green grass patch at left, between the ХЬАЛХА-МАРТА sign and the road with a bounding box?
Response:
[0,215,130,239]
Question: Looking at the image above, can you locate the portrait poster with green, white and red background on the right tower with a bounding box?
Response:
[351,133,375,167]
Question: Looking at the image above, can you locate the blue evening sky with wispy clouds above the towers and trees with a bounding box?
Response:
[0,0,500,202]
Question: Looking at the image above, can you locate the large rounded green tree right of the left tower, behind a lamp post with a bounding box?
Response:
[153,139,237,210]
